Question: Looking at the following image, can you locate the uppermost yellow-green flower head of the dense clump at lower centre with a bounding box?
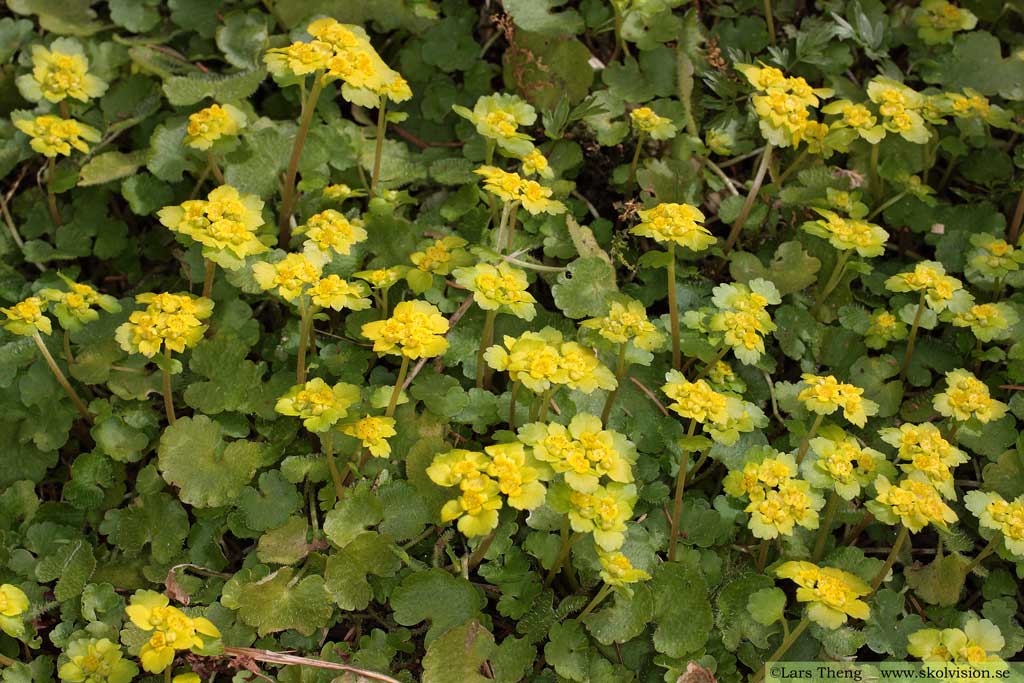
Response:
[519,413,636,494]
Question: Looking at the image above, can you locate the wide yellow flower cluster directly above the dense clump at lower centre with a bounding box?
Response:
[483,328,618,393]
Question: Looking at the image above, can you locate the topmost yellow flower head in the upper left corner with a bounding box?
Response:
[17,38,106,102]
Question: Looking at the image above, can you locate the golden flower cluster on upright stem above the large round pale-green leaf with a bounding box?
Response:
[115,292,213,358]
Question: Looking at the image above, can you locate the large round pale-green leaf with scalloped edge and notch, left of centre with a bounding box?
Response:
[158,415,263,508]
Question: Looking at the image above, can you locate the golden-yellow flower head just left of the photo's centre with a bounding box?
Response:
[362,301,449,360]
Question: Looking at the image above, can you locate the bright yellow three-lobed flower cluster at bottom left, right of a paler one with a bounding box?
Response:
[125,591,220,674]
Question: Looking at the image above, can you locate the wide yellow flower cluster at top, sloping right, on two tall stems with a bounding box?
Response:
[264,18,413,106]
